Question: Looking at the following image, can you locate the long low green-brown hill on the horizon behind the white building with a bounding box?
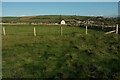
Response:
[2,15,117,25]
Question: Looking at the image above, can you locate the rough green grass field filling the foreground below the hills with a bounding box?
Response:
[2,25,120,80]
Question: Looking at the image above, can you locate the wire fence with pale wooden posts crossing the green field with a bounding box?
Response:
[2,24,120,36]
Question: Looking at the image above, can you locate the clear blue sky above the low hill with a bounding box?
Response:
[2,2,118,17]
